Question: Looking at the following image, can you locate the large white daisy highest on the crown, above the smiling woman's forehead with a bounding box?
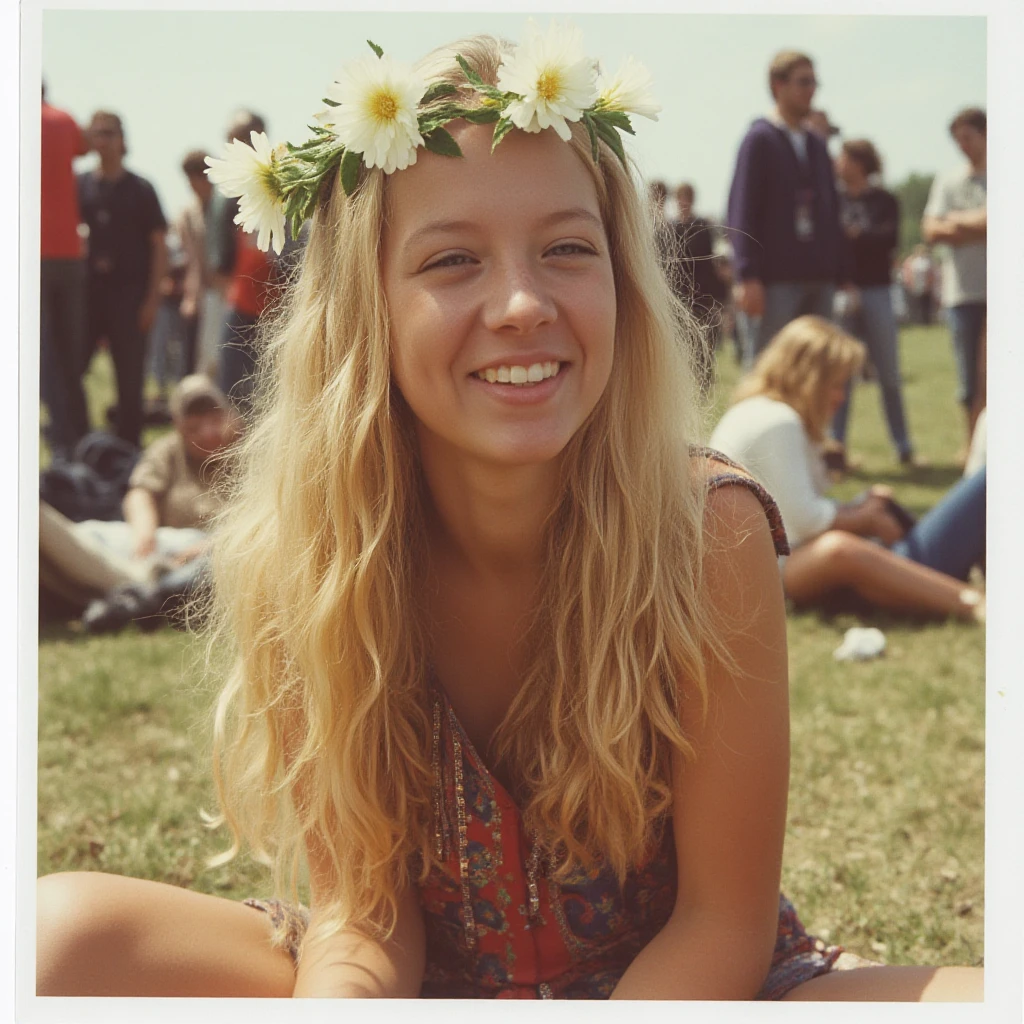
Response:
[498,20,597,142]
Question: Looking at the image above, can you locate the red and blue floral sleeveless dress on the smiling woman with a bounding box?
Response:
[247,453,843,999]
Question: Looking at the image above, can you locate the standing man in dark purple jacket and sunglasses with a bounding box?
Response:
[728,50,849,364]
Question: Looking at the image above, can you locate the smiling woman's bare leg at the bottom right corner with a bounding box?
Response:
[782,967,985,1002]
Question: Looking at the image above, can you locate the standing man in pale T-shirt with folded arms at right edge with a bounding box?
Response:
[921,106,988,452]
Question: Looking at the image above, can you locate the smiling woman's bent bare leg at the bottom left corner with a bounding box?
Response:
[36,871,295,997]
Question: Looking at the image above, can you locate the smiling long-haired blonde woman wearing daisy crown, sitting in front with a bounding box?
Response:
[37,25,981,999]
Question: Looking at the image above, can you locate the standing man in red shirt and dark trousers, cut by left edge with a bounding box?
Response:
[39,85,89,460]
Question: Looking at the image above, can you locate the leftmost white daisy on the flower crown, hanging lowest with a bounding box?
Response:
[206,131,287,256]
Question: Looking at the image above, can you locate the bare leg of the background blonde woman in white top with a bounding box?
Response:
[782,529,982,618]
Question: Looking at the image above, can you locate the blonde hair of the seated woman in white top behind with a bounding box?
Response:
[732,315,867,441]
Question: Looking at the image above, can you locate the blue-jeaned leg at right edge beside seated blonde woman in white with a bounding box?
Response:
[892,469,986,580]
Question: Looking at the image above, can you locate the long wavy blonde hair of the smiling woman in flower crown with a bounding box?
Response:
[209,37,726,935]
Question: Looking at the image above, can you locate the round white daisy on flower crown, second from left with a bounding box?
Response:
[316,54,427,174]
